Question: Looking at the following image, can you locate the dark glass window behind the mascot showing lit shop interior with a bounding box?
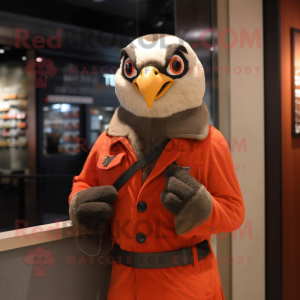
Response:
[0,0,217,231]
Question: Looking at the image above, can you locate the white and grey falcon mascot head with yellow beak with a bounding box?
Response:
[115,34,205,118]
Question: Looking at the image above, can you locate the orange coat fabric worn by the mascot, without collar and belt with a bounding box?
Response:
[69,126,245,300]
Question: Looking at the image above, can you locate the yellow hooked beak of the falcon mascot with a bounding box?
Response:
[132,66,174,108]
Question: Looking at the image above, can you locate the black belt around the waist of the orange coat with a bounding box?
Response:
[109,240,210,269]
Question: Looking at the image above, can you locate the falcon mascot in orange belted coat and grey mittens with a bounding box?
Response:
[69,35,245,300]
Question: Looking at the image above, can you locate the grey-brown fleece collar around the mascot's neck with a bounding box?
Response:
[106,101,210,140]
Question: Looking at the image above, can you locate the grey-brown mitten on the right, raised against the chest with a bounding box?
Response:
[160,165,213,234]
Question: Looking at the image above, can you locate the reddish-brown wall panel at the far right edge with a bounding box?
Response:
[281,0,300,300]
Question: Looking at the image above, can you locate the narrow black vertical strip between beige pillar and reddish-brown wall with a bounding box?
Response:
[263,0,282,300]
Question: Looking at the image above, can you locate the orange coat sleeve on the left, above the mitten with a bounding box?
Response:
[69,134,103,204]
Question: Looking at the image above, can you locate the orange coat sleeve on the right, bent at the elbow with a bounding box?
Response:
[180,128,245,237]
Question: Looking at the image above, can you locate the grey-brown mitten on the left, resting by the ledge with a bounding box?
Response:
[69,185,118,234]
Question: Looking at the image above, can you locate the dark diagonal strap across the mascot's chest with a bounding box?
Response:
[113,140,170,191]
